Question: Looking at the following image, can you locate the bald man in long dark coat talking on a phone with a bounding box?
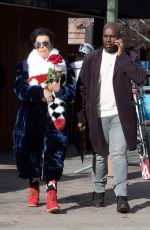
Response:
[75,22,146,213]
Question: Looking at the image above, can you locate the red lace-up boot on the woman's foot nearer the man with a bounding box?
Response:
[46,190,60,213]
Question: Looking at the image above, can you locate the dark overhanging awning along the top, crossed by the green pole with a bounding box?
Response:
[0,0,150,19]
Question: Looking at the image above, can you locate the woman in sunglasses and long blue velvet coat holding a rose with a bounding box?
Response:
[13,28,75,213]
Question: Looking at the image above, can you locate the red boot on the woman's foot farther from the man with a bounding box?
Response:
[28,185,40,207]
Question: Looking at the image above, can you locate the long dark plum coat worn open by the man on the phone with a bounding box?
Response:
[75,48,146,153]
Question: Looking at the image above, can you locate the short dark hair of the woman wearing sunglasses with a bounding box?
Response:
[30,27,55,45]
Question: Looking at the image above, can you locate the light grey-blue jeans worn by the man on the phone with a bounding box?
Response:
[92,115,128,196]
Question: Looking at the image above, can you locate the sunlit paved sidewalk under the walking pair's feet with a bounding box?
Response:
[0,145,150,230]
